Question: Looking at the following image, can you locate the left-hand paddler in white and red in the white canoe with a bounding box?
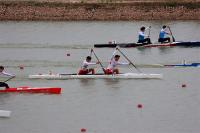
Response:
[78,56,99,75]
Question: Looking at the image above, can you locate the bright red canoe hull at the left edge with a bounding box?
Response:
[0,87,61,94]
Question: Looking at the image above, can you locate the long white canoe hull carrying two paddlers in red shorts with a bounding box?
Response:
[29,73,163,80]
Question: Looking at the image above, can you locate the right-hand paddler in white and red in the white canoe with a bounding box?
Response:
[105,55,130,74]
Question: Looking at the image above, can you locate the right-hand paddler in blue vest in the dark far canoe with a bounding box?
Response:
[158,25,171,43]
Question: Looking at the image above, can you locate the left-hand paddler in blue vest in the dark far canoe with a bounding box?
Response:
[138,26,152,44]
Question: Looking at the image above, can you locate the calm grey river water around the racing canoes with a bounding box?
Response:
[0,21,200,133]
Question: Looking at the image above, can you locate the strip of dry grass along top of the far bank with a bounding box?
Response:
[0,0,200,9]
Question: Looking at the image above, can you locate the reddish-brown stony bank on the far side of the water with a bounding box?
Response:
[0,0,200,21]
